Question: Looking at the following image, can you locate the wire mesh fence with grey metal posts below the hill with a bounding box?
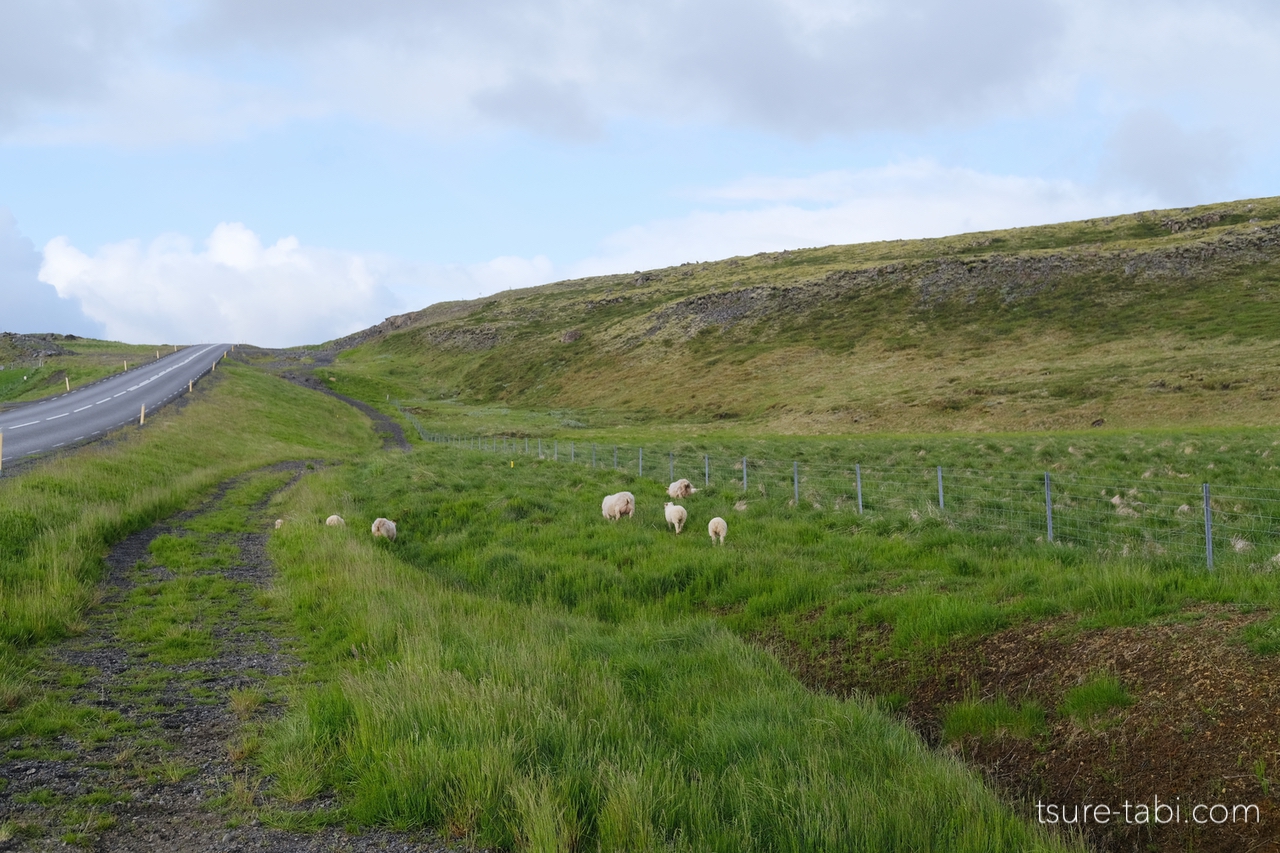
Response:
[401,409,1280,569]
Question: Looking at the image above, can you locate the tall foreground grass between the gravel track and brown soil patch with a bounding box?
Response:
[261,468,1070,853]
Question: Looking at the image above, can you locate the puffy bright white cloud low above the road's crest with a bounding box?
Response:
[40,223,549,346]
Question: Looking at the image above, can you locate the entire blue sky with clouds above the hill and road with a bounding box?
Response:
[0,0,1280,346]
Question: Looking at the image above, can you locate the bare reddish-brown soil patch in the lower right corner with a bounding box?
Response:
[767,608,1280,853]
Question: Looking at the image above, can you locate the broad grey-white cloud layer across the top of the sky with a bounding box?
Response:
[0,0,1280,143]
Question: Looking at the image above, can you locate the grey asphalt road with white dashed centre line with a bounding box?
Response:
[0,343,230,462]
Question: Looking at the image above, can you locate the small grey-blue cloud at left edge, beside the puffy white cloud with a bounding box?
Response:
[0,207,102,337]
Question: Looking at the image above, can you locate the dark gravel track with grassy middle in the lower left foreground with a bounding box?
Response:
[0,464,456,853]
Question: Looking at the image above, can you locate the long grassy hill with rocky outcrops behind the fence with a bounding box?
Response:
[325,199,1280,433]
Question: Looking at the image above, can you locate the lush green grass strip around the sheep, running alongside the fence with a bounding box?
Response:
[293,446,1280,653]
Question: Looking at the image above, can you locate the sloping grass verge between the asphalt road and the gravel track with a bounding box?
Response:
[0,365,376,704]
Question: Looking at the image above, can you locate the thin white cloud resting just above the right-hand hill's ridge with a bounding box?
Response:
[573,160,1152,275]
